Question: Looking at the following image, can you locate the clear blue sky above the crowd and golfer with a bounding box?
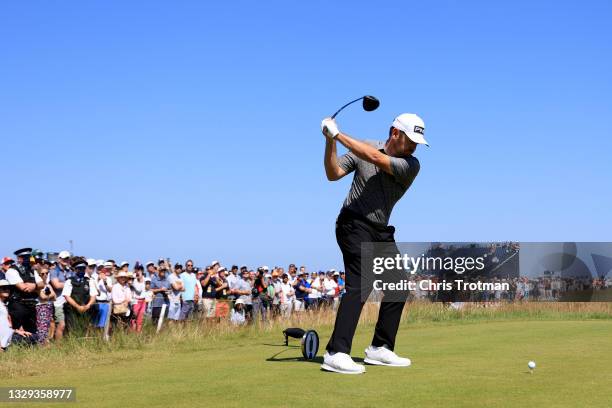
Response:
[0,1,612,269]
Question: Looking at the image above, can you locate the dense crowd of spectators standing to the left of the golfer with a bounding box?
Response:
[0,248,344,350]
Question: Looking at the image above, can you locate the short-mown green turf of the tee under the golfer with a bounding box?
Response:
[2,320,612,408]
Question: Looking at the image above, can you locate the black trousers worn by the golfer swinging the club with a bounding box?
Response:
[326,210,405,354]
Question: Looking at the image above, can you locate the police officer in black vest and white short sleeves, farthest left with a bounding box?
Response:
[6,248,44,333]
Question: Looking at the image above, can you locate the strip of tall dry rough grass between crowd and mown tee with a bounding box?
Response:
[0,302,612,378]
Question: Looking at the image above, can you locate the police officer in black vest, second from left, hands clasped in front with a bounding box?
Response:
[62,260,98,331]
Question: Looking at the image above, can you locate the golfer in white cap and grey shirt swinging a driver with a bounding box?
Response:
[321,113,427,374]
